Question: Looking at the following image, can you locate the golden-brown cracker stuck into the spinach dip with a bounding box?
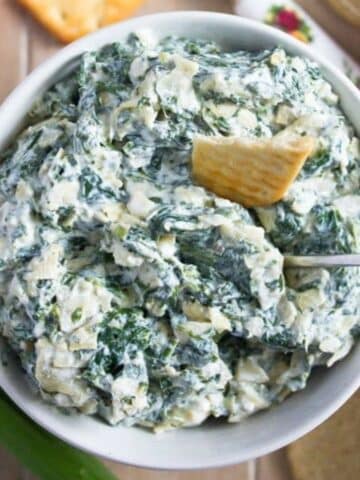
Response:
[192,130,315,207]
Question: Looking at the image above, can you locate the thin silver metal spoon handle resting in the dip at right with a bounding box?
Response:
[284,253,360,268]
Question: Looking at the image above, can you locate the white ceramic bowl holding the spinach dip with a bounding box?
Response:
[0,12,360,469]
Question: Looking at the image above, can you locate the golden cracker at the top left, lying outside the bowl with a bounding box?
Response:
[19,0,144,43]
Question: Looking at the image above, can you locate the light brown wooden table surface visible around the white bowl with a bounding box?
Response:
[0,0,360,480]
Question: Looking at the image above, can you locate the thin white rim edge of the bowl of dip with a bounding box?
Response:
[0,11,360,470]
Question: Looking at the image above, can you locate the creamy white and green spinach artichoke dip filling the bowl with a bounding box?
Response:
[0,34,360,431]
